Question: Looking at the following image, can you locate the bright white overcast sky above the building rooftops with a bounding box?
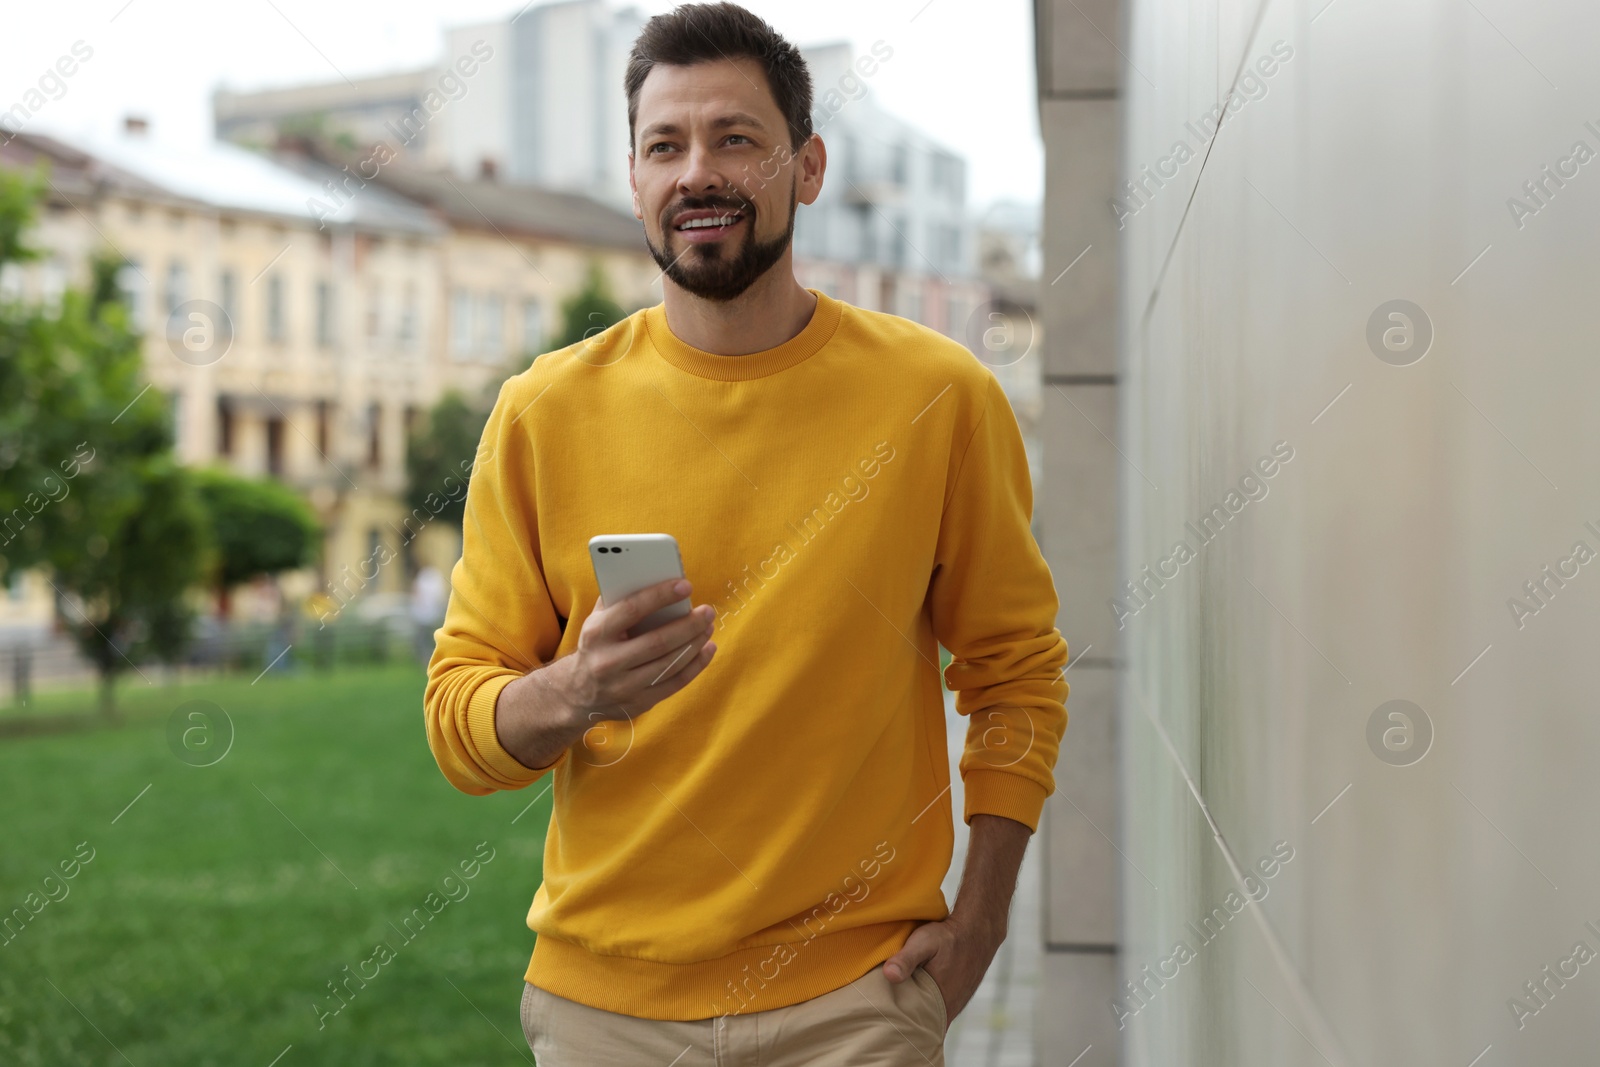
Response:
[0,0,1043,210]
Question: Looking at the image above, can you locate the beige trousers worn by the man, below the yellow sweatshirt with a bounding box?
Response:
[522,963,949,1067]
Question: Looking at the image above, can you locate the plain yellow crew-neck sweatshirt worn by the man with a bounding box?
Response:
[424,293,1067,1019]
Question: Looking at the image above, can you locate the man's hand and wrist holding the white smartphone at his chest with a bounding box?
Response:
[494,579,717,769]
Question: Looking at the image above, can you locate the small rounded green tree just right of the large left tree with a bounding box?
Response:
[195,469,322,617]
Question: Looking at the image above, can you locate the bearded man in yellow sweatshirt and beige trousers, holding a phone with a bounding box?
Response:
[424,3,1067,1067]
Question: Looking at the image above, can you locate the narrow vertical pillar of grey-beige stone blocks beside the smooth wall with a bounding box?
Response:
[1034,0,1138,1067]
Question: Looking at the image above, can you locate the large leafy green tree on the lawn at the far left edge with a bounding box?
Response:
[0,171,208,713]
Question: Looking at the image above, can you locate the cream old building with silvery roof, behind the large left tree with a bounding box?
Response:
[5,123,445,617]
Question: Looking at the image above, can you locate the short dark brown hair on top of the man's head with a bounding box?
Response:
[622,3,811,150]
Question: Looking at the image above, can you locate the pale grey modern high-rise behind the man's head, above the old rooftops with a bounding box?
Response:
[213,16,989,339]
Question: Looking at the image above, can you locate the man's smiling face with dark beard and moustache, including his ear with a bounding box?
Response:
[629,59,826,301]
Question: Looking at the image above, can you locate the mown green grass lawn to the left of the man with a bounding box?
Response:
[0,665,550,1067]
